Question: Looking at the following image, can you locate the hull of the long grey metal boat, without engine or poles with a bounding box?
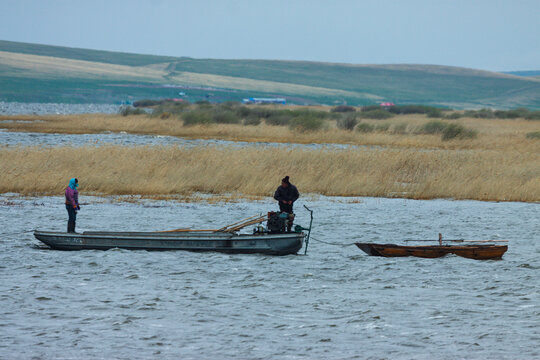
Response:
[34,231,305,255]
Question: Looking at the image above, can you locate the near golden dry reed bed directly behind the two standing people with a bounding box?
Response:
[0,146,540,202]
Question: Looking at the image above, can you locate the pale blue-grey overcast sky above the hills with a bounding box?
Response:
[0,0,540,71]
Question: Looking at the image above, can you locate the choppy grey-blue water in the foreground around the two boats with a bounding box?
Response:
[0,195,540,359]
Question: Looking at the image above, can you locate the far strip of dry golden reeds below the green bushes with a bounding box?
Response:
[0,114,540,152]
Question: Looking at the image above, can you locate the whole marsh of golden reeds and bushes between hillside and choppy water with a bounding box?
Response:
[0,102,540,201]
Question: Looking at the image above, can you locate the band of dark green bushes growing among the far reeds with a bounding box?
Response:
[127,100,540,141]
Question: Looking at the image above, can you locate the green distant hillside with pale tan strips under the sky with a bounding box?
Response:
[0,41,540,109]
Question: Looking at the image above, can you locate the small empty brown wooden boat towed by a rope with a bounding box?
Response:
[355,243,508,260]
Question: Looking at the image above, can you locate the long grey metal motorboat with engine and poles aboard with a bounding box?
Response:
[34,205,313,255]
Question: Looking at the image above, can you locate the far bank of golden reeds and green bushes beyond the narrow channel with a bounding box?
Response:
[0,100,540,148]
